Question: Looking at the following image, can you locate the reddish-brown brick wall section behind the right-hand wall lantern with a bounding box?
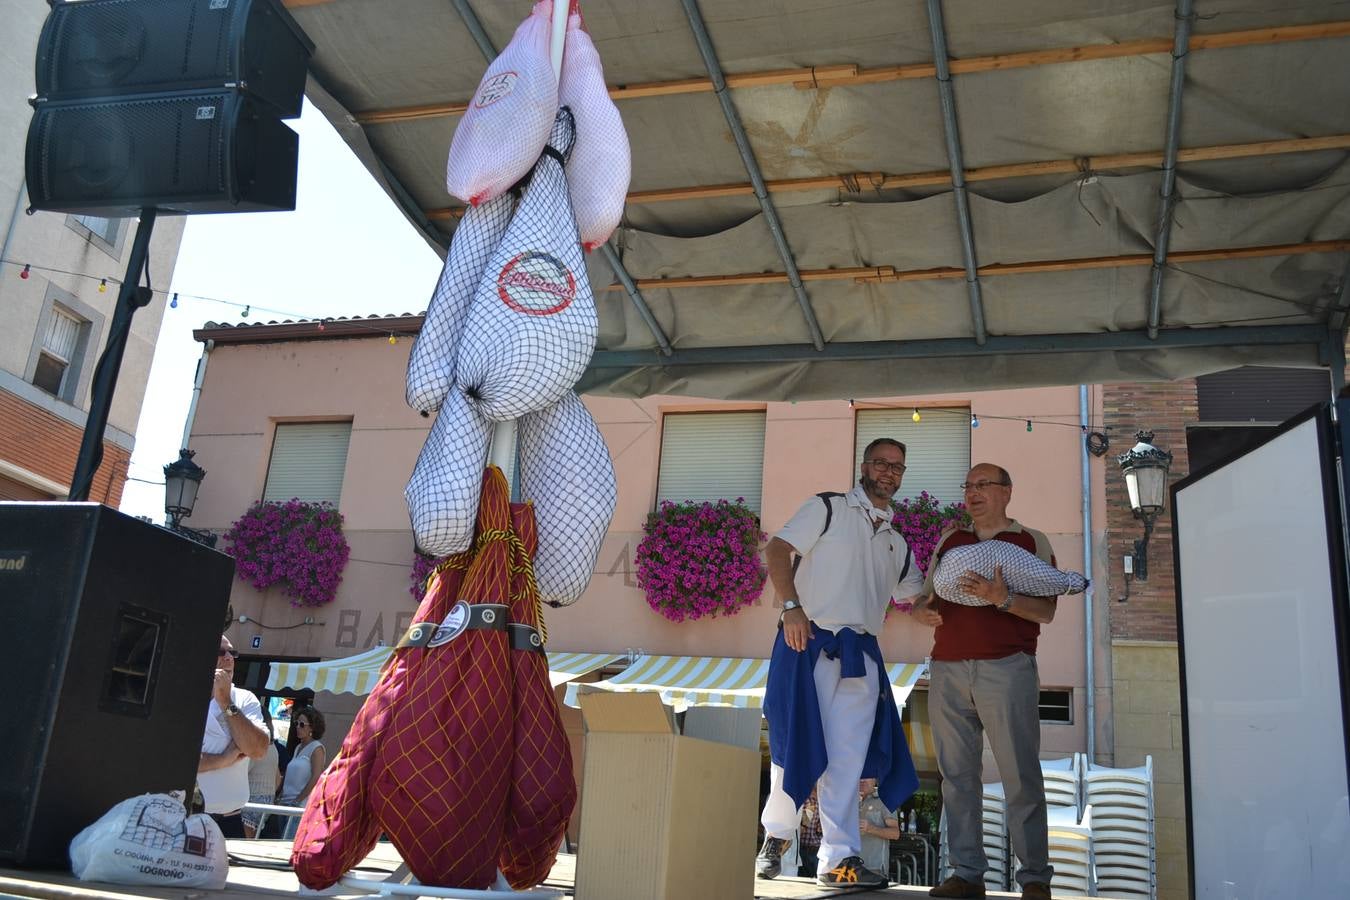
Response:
[1102,379,1199,641]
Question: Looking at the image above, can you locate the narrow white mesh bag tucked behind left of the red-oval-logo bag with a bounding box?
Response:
[406,193,516,413]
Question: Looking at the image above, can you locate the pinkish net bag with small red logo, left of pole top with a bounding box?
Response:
[446,0,558,206]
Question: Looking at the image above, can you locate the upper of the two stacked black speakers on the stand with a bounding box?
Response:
[36,0,313,119]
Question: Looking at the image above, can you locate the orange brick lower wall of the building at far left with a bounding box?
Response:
[0,390,131,507]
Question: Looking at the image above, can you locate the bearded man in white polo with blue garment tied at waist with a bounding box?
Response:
[755,437,923,888]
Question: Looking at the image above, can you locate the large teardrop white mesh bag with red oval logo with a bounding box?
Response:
[455,108,599,421]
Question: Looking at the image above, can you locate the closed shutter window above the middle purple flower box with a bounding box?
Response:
[656,412,764,513]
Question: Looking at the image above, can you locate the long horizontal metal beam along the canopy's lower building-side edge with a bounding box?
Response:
[590,324,1327,370]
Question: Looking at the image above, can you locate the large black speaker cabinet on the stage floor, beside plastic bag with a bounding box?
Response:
[0,503,235,866]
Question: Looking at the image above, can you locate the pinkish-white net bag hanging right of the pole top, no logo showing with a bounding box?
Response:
[558,12,632,251]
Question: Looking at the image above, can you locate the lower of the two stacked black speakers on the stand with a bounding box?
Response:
[27,90,300,216]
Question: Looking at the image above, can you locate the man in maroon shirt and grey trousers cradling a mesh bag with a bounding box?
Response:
[911,463,1056,900]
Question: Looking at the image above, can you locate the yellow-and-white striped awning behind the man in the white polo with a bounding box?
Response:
[564,656,927,711]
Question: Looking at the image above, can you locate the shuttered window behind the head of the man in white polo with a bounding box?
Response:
[853,406,971,503]
